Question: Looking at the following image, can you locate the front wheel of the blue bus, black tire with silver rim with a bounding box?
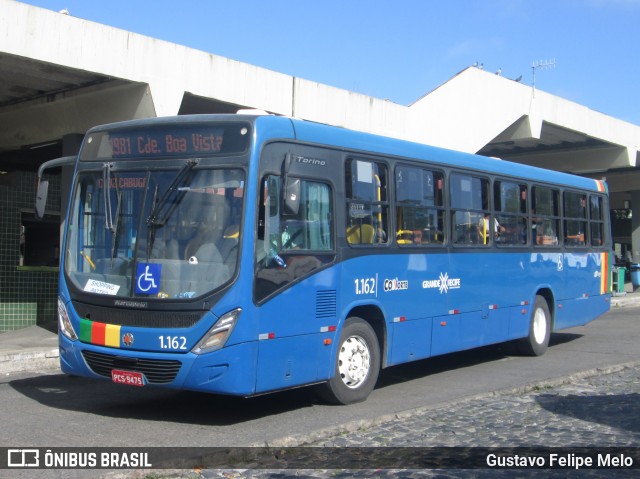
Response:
[318,317,380,404]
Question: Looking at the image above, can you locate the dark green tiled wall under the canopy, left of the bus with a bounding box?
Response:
[0,172,60,331]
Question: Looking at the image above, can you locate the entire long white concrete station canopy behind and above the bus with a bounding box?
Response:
[0,0,640,199]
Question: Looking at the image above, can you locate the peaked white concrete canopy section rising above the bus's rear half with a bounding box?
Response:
[404,67,640,200]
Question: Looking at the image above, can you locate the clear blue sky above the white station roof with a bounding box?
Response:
[17,0,640,125]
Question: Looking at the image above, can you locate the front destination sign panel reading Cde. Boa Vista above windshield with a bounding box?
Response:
[81,123,250,161]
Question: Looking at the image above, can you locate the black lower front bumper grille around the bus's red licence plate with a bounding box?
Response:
[82,351,182,384]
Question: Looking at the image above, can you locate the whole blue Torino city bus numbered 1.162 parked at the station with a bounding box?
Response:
[40,115,611,404]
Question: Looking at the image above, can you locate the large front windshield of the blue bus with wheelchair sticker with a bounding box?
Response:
[64,167,245,300]
